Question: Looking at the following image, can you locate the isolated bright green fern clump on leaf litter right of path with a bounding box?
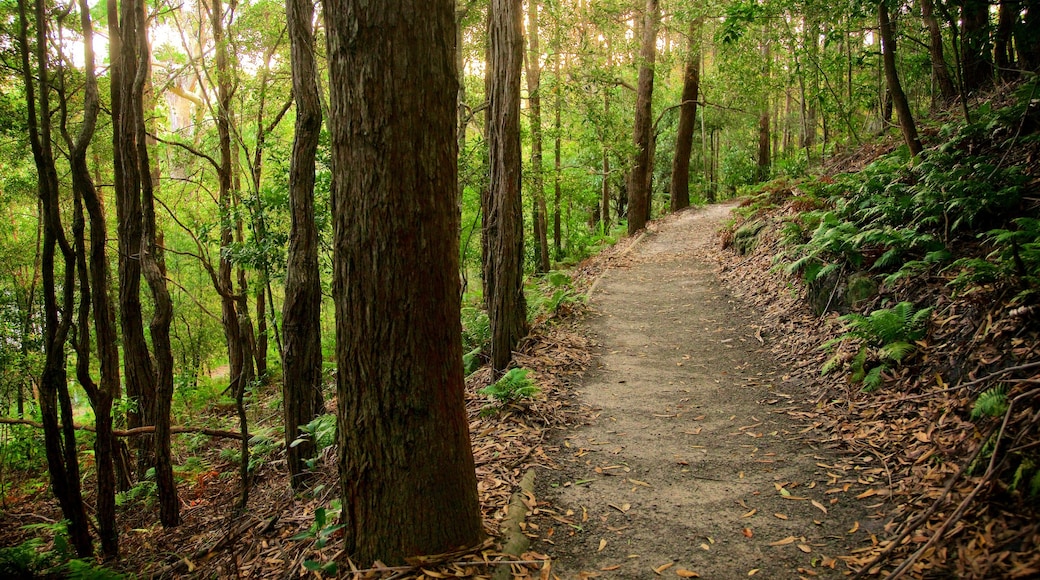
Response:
[821,302,932,392]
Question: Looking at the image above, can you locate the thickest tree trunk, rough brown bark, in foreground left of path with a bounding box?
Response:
[323,0,482,564]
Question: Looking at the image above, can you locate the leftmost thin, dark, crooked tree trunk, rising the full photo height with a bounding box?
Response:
[18,0,94,558]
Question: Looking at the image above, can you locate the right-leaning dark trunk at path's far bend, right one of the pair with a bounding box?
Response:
[672,18,702,216]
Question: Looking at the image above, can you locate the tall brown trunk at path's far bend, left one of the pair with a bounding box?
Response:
[628,0,660,235]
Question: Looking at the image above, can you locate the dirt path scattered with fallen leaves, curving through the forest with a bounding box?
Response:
[530,206,868,579]
